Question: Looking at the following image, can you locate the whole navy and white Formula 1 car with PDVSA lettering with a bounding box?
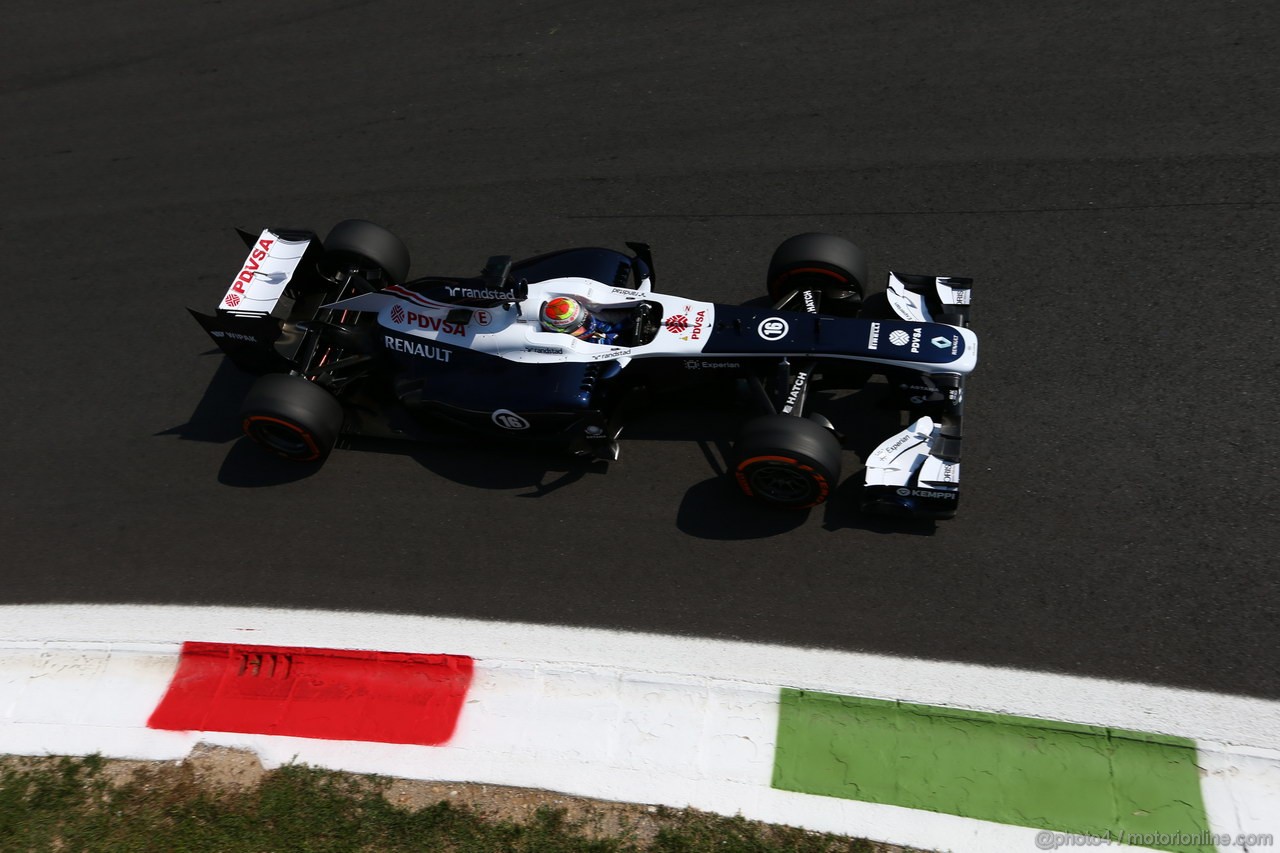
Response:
[192,219,978,519]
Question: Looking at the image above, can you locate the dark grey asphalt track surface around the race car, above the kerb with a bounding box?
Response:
[0,0,1280,697]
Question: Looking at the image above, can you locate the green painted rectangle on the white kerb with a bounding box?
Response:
[773,689,1213,853]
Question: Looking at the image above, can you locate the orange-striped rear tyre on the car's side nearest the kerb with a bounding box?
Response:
[241,373,343,462]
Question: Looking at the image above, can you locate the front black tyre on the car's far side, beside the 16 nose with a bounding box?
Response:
[768,233,867,316]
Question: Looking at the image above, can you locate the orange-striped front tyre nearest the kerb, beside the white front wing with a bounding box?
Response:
[733,415,841,510]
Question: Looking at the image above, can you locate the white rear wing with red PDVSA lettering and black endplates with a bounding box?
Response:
[188,228,324,373]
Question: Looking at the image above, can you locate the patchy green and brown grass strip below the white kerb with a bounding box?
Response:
[0,756,888,853]
